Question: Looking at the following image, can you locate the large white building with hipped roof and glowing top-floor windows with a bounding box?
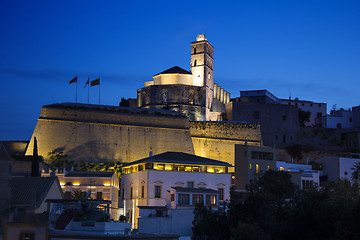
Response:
[121,152,232,228]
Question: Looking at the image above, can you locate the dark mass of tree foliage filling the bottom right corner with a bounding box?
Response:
[193,171,360,240]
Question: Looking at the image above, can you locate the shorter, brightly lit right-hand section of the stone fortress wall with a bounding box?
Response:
[190,122,262,166]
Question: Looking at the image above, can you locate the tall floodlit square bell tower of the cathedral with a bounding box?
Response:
[190,34,214,120]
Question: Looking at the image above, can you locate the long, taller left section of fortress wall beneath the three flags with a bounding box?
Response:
[26,104,194,162]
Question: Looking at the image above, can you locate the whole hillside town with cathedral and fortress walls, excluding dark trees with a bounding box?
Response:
[0,34,360,240]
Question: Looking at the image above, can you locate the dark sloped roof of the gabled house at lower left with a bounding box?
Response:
[11,176,57,208]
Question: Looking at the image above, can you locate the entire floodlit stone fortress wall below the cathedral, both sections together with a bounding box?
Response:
[26,104,262,169]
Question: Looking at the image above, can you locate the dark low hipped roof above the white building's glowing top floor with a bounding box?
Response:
[123,152,232,167]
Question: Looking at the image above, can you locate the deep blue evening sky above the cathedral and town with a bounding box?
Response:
[0,0,360,140]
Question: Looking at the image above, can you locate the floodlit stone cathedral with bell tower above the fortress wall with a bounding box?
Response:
[137,34,230,121]
